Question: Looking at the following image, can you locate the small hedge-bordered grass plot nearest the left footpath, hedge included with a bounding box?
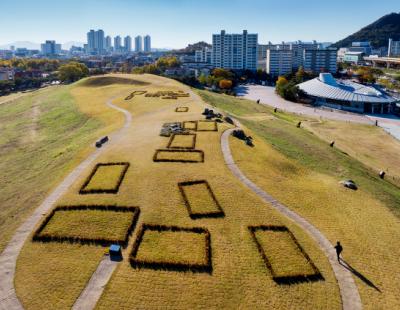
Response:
[79,162,129,194]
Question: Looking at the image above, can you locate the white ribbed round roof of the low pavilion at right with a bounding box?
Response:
[297,73,398,104]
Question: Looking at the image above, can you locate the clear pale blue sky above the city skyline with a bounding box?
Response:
[0,0,400,47]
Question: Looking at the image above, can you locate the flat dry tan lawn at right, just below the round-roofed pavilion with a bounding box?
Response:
[303,121,400,185]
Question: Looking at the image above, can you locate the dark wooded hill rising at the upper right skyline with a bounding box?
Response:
[334,13,400,48]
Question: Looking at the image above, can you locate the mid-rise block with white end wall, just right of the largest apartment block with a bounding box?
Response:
[266,49,293,76]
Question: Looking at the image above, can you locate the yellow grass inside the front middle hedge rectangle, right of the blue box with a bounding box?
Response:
[136,230,206,264]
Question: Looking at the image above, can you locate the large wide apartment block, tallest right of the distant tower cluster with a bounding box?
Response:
[212,30,258,70]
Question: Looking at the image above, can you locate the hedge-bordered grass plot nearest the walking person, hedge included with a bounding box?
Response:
[249,226,323,284]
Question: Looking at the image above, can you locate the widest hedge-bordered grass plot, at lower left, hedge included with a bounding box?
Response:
[32,205,140,247]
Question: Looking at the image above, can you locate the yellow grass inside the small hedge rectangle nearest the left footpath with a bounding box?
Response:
[82,164,126,191]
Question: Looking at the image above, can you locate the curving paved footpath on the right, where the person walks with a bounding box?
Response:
[221,126,362,310]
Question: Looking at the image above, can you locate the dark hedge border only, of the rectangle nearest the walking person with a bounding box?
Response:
[248,225,324,284]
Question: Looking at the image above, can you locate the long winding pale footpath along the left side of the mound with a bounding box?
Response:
[0,98,132,310]
